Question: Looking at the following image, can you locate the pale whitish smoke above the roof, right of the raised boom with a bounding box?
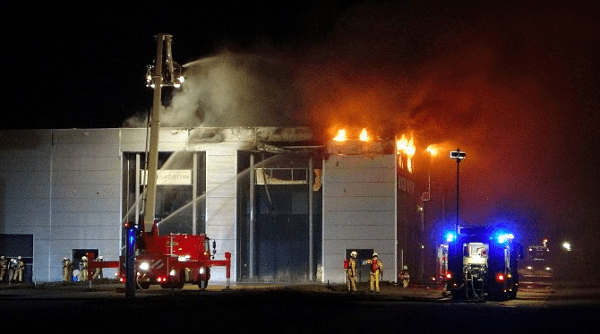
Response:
[125,52,296,127]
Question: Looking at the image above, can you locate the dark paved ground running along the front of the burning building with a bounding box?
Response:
[0,283,600,334]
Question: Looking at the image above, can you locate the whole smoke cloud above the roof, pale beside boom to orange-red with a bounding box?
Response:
[124,1,600,253]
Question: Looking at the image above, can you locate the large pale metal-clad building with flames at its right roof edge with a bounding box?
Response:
[0,127,423,282]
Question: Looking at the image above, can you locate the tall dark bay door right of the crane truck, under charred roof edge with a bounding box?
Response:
[238,151,321,282]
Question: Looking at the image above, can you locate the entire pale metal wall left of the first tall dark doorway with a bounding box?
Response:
[0,129,121,281]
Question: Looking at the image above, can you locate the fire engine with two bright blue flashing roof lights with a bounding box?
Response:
[446,227,523,300]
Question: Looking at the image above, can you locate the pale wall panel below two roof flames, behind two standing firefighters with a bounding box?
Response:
[322,155,397,283]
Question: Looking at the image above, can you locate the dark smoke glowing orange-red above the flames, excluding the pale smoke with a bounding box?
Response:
[296,3,600,244]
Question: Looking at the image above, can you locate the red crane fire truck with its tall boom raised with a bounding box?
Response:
[88,34,231,292]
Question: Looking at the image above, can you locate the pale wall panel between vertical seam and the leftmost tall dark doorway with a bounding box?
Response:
[46,129,121,281]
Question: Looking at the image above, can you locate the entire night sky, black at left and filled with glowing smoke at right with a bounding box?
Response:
[2,0,600,258]
